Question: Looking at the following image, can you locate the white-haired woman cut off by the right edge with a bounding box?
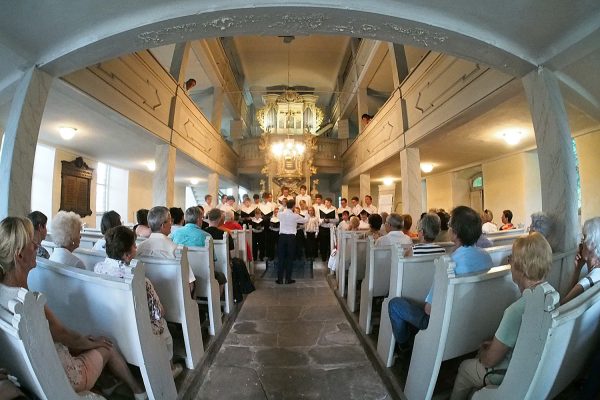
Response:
[560,217,600,304]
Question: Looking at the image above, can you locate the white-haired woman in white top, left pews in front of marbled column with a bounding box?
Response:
[50,211,85,268]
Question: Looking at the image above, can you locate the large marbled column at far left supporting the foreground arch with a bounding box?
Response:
[0,67,52,219]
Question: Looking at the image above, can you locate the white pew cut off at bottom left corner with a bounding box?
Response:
[0,284,95,400]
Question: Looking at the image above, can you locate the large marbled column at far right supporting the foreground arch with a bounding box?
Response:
[523,67,579,251]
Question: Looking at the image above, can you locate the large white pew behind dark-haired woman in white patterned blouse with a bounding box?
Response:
[28,258,177,399]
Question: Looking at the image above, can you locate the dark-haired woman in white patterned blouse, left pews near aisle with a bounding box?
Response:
[94,226,182,376]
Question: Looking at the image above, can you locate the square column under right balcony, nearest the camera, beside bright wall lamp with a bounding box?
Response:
[400,148,422,225]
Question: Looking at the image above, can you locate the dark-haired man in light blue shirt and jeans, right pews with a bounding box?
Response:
[380,206,493,346]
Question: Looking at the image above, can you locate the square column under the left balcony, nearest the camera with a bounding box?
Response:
[152,144,177,207]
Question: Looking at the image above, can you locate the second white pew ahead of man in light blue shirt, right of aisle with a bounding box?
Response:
[358,237,394,335]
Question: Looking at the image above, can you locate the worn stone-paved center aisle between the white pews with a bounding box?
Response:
[186,262,391,400]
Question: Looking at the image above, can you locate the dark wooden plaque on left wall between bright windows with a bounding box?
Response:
[60,157,94,218]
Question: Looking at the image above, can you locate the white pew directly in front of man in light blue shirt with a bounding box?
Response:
[378,246,512,367]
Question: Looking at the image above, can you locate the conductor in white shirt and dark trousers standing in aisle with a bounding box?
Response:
[275,199,308,284]
